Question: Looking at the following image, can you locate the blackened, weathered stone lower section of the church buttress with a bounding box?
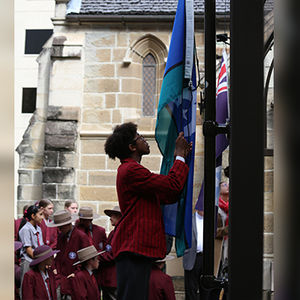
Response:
[42,106,79,210]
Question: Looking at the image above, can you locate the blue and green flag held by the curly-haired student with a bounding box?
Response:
[155,0,197,256]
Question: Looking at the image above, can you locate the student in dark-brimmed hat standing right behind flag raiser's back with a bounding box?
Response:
[99,206,122,300]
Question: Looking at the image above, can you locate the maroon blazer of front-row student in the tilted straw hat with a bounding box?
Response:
[70,269,100,300]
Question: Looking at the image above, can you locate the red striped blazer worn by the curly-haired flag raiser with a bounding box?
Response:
[112,158,189,258]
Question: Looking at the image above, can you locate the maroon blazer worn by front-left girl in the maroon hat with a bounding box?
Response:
[22,269,57,300]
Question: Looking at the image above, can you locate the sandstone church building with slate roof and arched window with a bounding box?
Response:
[17,0,273,290]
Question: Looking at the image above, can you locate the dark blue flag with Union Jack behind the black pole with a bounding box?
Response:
[195,50,229,210]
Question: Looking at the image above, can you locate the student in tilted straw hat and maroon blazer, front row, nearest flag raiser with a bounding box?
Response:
[70,245,101,300]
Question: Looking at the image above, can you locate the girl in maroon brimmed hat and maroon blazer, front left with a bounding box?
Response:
[22,245,59,300]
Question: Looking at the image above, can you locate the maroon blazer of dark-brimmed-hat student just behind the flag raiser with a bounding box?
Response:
[99,230,117,288]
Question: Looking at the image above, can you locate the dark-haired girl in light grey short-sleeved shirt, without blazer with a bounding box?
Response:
[19,205,44,292]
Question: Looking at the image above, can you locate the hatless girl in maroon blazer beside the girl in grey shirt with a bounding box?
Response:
[39,199,57,249]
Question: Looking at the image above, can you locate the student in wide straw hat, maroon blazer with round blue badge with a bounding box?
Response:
[48,210,91,297]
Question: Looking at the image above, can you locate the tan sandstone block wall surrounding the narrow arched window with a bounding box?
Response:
[77,28,203,231]
